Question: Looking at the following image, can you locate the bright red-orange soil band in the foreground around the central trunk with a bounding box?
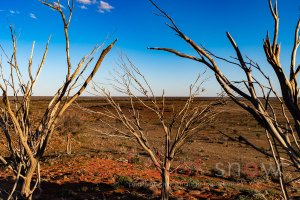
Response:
[0,155,296,199]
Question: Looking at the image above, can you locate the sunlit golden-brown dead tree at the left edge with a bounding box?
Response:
[0,0,115,199]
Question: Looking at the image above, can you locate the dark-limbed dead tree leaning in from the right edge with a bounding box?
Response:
[150,0,300,199]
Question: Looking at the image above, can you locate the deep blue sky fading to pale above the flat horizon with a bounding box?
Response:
[0,0,300,96]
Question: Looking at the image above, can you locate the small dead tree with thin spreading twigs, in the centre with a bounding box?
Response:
[88,57,218,199]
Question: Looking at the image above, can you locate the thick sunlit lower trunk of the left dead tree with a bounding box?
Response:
[21,160,38,200]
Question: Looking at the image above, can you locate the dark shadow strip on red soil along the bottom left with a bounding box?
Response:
[0,177,159,200]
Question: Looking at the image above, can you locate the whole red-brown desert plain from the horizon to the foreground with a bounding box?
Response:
[0,98,300,200]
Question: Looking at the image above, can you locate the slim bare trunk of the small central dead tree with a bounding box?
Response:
[161,160,171,200]
